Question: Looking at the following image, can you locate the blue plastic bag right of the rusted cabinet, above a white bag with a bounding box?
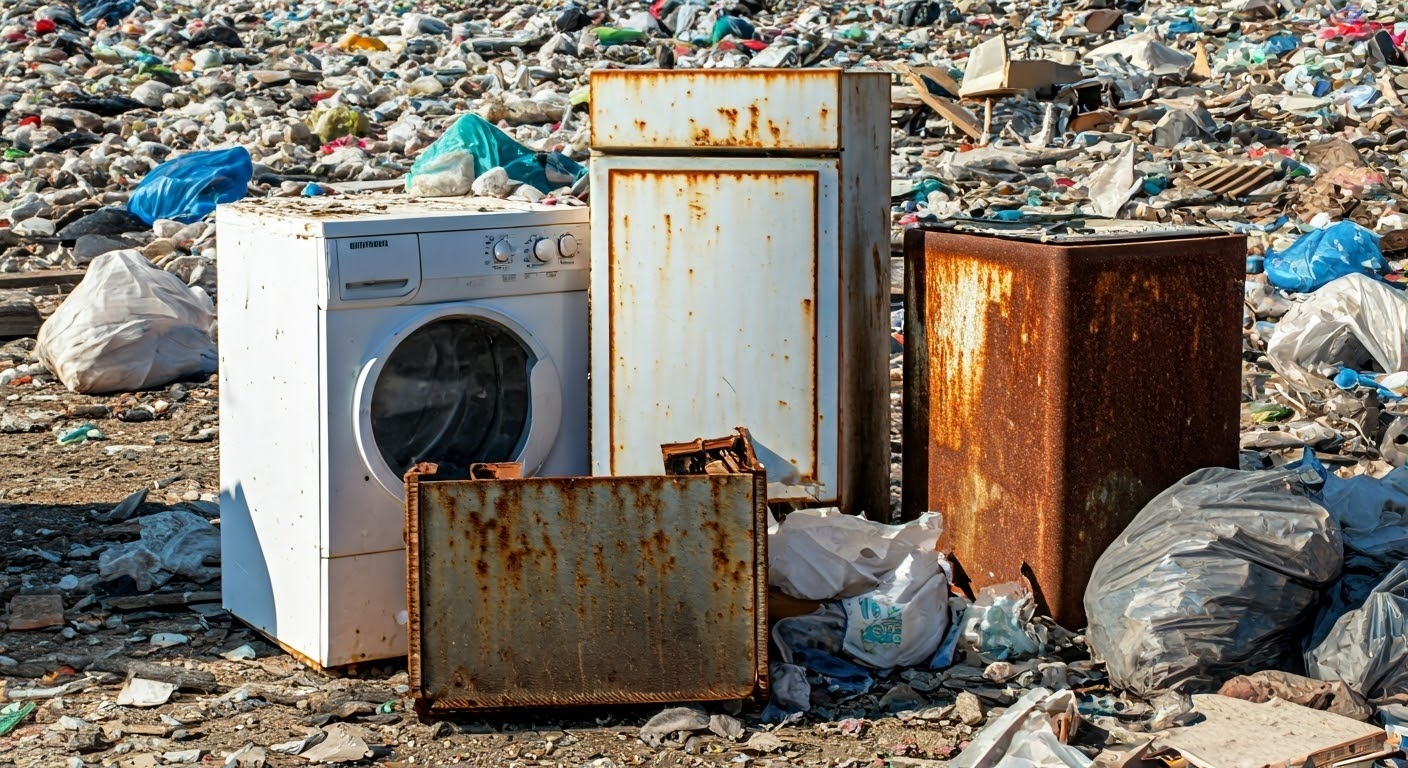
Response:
[1266,221,1388,293]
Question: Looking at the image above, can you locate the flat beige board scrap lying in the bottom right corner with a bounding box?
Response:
[1153,693,1387,768]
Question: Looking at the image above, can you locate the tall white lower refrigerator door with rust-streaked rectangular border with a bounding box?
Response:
[590,156,839,502]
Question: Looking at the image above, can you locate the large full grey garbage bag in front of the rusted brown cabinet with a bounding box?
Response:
[1086,454,1343,698]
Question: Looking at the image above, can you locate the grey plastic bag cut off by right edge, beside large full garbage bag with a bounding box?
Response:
[1305,561,1408,702]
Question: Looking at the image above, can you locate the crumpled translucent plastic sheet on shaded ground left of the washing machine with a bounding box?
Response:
[97,509,220,592]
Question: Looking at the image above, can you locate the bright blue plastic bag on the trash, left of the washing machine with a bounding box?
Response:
[127,147,255,224]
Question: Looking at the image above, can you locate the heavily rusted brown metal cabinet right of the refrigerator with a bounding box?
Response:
[903,222,1246,627]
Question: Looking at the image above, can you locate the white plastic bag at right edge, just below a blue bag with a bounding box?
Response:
[1266,275,1408,392]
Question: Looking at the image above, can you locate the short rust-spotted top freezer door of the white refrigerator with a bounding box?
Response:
[591,69,850,152]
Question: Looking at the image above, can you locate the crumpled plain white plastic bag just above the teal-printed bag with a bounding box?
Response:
[767,509,943,600]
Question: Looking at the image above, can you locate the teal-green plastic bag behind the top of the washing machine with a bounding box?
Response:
[406,114,587,194]
